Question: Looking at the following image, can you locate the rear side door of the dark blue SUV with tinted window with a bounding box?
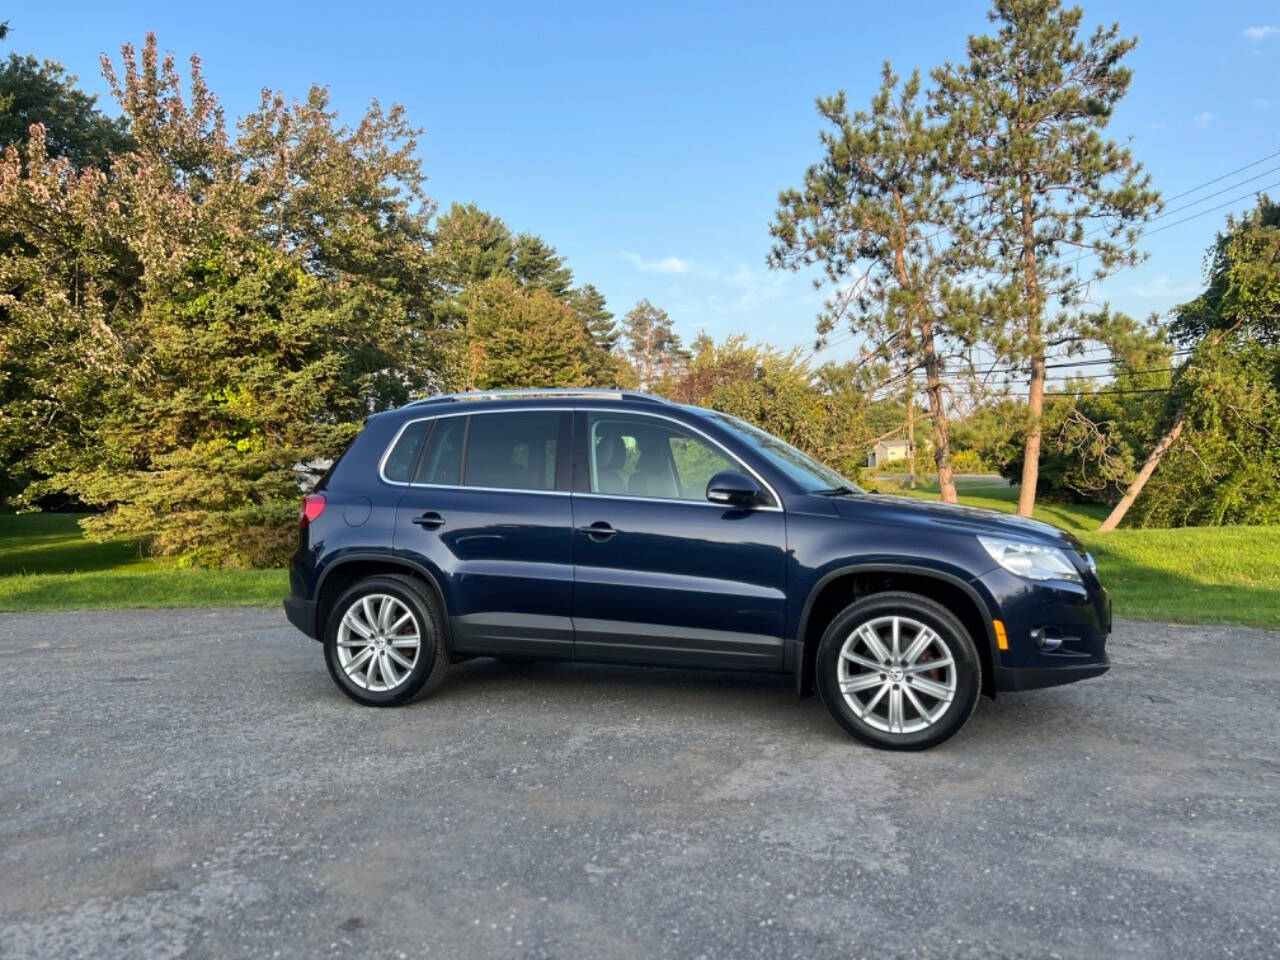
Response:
[394,408,573,658]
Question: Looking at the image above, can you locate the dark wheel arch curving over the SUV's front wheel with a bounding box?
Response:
[792,563,996,698]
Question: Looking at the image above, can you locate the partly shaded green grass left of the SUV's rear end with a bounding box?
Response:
[0,513,289,611]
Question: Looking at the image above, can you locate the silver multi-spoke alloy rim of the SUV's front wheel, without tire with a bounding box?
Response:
[836,616,956,733]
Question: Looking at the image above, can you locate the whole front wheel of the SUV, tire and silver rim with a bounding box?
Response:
[815,593,982,750]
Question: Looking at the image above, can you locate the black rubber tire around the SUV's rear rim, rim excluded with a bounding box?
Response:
[324,573,449,707]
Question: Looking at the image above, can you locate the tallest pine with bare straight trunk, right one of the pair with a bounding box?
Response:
[932,0,1158,516]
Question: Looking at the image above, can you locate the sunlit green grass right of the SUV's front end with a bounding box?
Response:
[901,484,1280,628]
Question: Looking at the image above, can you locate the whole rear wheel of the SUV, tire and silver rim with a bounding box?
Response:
[324,576,448,707]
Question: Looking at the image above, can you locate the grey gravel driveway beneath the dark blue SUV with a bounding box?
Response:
[0,609,1280,960]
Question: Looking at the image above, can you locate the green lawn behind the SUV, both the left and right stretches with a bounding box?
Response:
[0,504,1280,628]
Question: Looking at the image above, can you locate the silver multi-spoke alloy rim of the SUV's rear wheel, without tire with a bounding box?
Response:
[338,594,422,694]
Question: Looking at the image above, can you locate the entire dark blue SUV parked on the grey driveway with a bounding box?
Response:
[284,390,1111,749]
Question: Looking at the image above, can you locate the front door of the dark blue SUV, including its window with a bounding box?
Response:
[572,410,786,669]
